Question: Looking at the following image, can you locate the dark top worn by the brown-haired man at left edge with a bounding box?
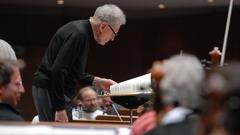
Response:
[0,103,24,121]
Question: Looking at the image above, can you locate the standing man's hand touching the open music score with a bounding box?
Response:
[93,77,116,90]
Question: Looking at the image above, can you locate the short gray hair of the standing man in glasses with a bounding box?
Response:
[91,4,126,26]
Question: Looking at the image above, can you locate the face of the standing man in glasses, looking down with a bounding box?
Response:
[98,22,120,46]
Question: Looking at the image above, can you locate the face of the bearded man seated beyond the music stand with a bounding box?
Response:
[82,90,98,113]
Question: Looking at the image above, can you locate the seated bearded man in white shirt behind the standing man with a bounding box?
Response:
[72,86,103,120]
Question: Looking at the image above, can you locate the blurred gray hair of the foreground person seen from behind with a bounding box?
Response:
[160,54,205,108]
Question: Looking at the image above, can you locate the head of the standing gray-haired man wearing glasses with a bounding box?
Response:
[89,4,126,45]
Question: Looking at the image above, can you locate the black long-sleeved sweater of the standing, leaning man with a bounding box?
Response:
[33,20,94,120]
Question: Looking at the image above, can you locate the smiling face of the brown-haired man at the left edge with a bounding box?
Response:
[0,69,25,106]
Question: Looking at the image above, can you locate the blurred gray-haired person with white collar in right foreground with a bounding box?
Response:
[146,54,205,135]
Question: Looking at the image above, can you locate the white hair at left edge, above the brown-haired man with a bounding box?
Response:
[0,39,17,60]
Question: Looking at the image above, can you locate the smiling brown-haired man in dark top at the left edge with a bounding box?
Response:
[0,59,25,121]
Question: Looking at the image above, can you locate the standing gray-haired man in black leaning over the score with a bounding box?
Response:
[32,4,126,122]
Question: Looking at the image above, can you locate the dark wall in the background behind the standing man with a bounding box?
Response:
[0,6,240,120]
